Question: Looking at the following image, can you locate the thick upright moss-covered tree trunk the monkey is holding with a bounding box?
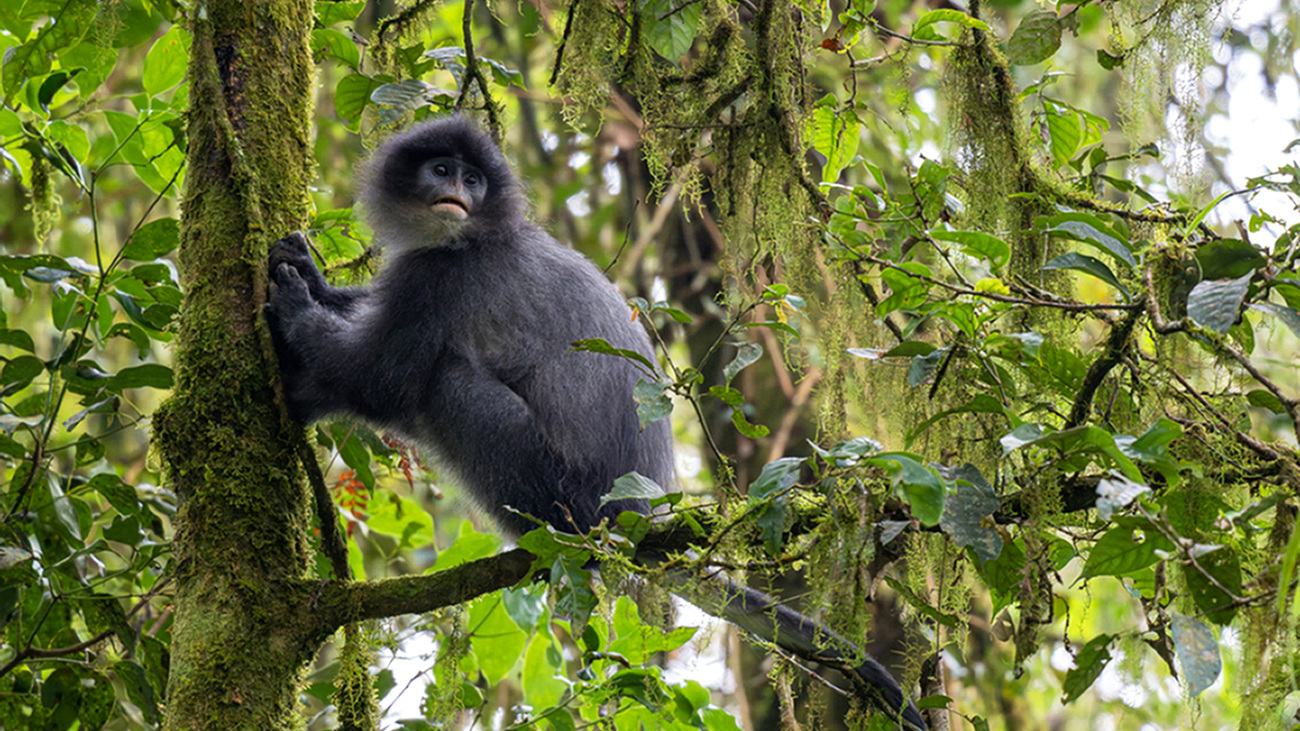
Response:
[155,0,324,730]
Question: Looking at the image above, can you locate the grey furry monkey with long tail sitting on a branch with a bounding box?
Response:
[265,114,927,730]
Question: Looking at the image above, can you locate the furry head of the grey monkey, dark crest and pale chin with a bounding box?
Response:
[358,114,524,252]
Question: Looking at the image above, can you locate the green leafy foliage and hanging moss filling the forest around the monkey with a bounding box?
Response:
[0,0,1300,730]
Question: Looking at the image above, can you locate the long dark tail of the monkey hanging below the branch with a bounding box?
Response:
[667,570,930,731]
